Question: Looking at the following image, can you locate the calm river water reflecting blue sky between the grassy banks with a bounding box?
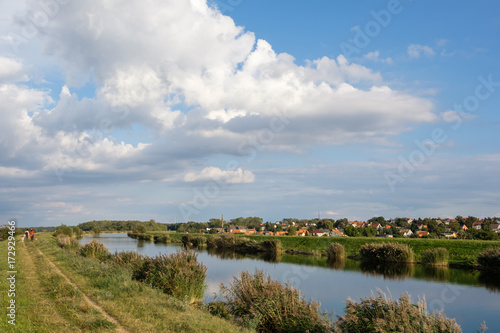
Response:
[80,234,500,333]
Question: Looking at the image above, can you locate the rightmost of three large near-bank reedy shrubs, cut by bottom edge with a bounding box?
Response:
[337,291,461,333]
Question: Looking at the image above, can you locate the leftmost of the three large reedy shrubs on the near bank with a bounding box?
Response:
[132,249,207,303]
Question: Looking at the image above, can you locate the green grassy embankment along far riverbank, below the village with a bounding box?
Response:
[144,232,500,267]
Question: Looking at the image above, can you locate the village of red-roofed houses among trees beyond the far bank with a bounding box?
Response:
[200,216,500,239]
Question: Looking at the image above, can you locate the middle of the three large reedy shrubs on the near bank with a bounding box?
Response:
[222,270,329,332]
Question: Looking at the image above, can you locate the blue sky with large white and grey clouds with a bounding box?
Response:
[0,0,500,227]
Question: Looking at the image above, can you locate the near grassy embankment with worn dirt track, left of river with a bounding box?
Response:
[0,233,250,332]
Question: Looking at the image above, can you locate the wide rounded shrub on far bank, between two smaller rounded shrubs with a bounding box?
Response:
[359,243,415,262]
